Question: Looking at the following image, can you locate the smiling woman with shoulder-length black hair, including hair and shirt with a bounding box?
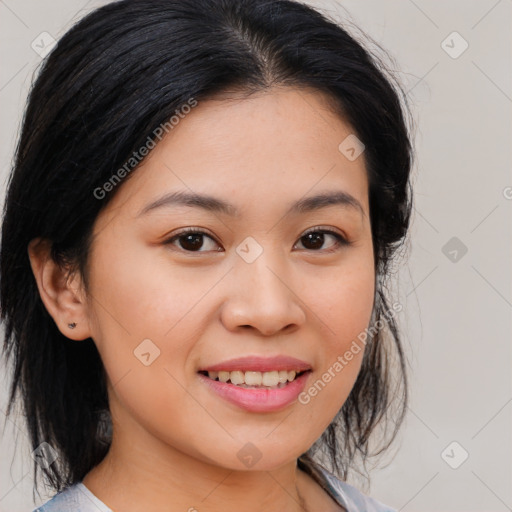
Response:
[0,0,412,512]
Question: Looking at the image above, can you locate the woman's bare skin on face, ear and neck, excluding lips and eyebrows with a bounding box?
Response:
[29,88,375,512]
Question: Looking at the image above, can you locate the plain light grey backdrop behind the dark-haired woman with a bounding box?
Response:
[0,0,512,512]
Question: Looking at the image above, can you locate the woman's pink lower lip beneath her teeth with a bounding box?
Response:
[198,371,311,412]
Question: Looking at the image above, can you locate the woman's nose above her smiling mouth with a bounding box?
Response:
[221,251,306,336]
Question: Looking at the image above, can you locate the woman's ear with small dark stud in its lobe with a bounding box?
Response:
[28,238,91,340]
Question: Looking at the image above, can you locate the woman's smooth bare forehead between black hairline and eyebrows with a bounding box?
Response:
[98,88,368,222]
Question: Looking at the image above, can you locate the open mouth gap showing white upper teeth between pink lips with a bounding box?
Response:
[198,369,311,389]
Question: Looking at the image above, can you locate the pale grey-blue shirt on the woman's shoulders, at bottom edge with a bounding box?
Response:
[33,458,397,512]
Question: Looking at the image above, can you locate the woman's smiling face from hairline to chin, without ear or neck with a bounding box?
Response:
[82,88,375,470]
